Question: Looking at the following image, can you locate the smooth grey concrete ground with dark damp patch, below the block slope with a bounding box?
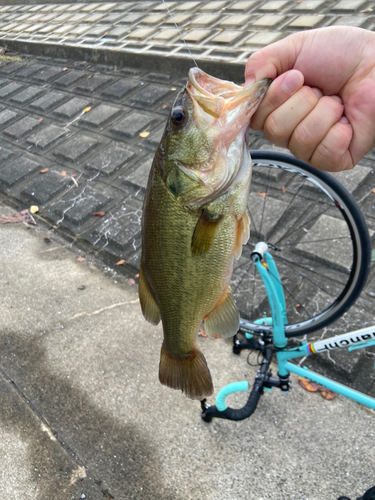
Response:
[0,206,375,500]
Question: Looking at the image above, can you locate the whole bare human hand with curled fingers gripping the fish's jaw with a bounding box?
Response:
[245,27,375,171]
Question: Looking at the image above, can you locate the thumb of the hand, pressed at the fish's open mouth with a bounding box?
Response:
[245,33,304,87]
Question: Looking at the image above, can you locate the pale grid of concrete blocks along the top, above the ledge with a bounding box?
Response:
[0,0,374,72]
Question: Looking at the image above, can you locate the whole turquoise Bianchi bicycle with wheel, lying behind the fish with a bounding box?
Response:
[201,151,375,422]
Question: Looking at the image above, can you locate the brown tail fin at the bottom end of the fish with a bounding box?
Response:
[159,346,214,400]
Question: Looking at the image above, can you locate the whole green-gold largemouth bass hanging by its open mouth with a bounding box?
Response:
[139,68,271,400]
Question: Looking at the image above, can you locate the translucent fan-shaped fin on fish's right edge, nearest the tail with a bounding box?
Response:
[204,287,240,338]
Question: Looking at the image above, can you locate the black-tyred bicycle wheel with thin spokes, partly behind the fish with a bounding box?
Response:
[231,150,371,337]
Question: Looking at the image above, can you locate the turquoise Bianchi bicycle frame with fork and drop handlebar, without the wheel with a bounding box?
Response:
[201,243,375,422]
